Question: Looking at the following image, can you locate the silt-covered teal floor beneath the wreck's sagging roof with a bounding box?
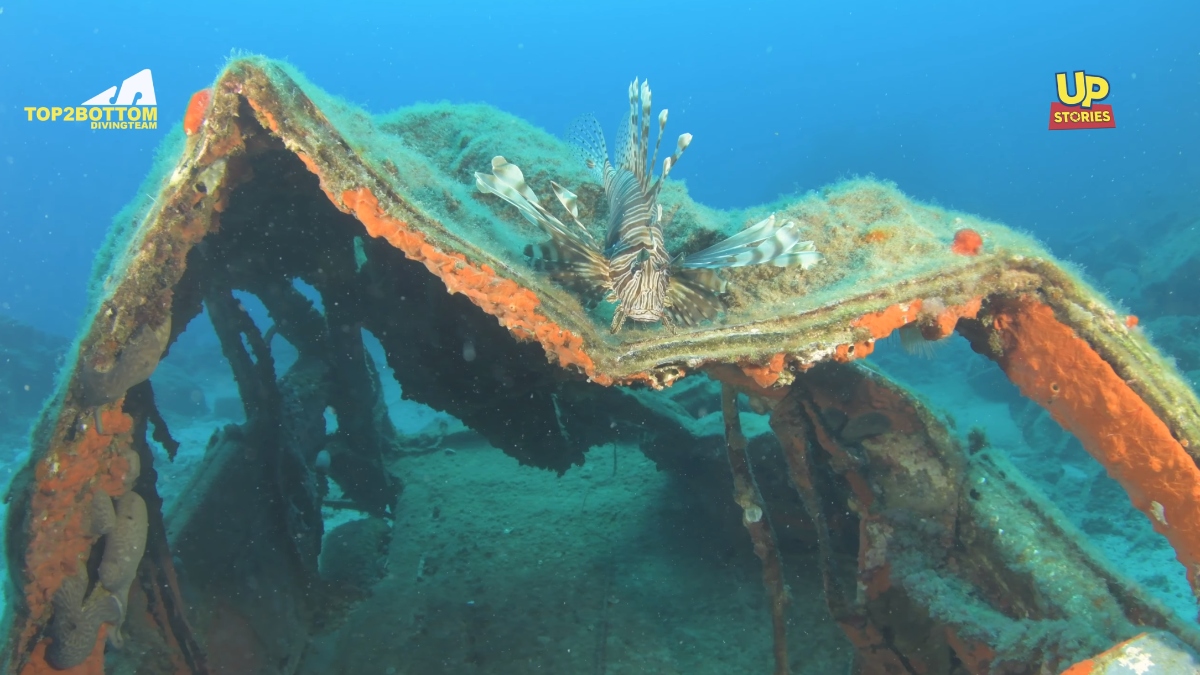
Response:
[294,437,851,675]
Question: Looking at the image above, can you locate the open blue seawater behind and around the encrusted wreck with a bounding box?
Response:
[0,0,1200,667]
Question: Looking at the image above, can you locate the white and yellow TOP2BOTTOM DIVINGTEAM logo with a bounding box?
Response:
[25,68,158,130]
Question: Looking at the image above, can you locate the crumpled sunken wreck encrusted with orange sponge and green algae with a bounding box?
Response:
[5,59,1200,675]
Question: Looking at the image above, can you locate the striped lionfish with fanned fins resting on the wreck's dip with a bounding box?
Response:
[475,79,821,333]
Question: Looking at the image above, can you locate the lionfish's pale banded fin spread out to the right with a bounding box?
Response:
[679,214,821,269]
